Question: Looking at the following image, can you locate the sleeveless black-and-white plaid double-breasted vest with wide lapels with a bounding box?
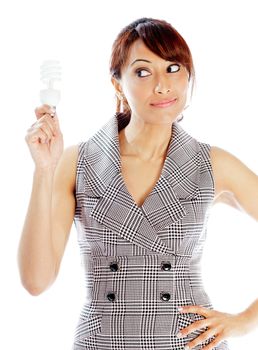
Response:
[73,115,228,350]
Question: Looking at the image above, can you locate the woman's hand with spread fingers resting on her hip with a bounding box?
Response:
[176,305,250,350]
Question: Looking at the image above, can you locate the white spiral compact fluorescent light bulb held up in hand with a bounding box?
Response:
[40,60,61,107]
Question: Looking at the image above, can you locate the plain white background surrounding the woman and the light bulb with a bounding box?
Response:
[0,0,258,350]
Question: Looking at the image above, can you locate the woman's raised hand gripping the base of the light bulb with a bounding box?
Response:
[25,104,64,169]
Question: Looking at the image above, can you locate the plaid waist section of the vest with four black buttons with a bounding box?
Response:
[82,255,211,312]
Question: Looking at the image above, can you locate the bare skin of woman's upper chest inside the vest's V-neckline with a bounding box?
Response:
[121,156,164,207]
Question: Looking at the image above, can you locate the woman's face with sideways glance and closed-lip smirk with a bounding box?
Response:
[112,39,189,124]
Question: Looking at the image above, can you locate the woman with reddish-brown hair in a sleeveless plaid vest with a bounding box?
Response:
[19,18,258,350]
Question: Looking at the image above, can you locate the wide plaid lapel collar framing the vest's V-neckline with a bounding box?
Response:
[85,115,200,255]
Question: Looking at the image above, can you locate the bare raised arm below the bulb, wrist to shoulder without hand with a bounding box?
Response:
[18,146,78,295]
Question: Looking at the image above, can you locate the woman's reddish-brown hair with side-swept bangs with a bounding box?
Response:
[109,17,195,121]
